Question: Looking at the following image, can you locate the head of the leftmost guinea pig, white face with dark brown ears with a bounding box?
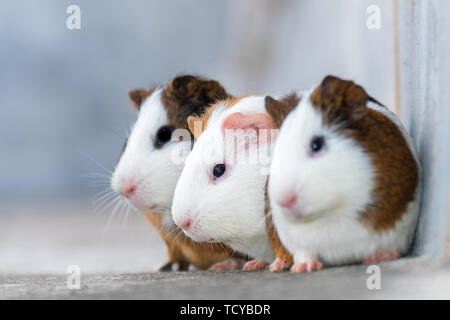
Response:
[111,75,227,220]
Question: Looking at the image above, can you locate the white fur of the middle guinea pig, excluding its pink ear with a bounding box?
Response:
[172,96,274,261]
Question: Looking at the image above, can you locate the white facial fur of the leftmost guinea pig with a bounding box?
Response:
[111,89,190,227]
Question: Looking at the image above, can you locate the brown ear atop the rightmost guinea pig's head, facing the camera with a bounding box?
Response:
[311,76,370,123]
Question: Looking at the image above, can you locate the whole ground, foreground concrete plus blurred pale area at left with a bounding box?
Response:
[0,205,450,299]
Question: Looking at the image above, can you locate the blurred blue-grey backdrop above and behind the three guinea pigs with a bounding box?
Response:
[0,0,395,201]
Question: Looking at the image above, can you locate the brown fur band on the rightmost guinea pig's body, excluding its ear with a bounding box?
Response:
[354,110,419,231]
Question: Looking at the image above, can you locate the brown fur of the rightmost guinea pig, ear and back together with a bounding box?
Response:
[311,76,419,232]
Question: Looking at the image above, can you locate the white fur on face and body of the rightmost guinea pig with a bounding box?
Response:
[269,91,420,265]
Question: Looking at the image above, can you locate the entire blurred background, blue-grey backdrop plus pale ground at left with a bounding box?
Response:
[0,0,446,272]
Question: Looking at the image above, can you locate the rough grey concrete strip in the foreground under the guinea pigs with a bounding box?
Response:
[0,258,450,299]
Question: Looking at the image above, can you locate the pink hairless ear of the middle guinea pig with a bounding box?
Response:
[222,112,275,131]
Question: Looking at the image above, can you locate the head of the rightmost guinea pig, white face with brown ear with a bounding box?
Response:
[269,76,374,220]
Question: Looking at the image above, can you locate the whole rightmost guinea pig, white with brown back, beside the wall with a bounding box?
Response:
[268,76,421,272]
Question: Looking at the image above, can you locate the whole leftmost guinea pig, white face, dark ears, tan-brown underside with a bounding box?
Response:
[111,75,246,271]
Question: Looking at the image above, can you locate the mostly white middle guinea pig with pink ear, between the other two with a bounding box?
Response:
[172,96,280,270]
